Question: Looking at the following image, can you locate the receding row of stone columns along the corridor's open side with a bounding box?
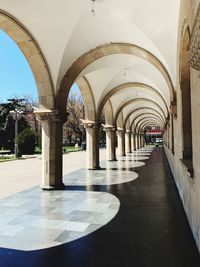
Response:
[36,111,144,190]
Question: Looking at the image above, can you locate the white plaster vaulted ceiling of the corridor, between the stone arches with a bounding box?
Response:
[0,0,180,130]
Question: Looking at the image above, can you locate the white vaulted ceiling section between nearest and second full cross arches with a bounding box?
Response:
[82,54,170,107]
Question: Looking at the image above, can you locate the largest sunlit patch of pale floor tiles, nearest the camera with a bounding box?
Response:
[0,187,120,251]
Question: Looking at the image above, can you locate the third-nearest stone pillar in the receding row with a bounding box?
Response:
[103,125,116,161]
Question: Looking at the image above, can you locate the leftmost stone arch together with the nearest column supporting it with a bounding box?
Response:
[0,10,63,189]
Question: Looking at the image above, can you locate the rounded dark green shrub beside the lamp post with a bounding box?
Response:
[18,128,35,155]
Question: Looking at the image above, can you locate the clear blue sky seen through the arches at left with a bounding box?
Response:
[0,30,79,102]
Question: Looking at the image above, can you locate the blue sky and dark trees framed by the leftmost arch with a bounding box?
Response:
[0,30,40,156]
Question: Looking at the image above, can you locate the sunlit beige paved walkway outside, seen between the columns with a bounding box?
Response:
[0,149,106,199]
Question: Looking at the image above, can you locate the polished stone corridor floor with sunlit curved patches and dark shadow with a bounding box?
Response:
[0,148,200,267]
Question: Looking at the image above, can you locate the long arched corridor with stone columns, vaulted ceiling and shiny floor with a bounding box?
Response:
[0,0,200,267]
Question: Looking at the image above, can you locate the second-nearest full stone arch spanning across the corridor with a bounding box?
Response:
[97,82,169,117]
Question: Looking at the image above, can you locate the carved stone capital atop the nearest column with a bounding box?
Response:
[34,109,61,122]
